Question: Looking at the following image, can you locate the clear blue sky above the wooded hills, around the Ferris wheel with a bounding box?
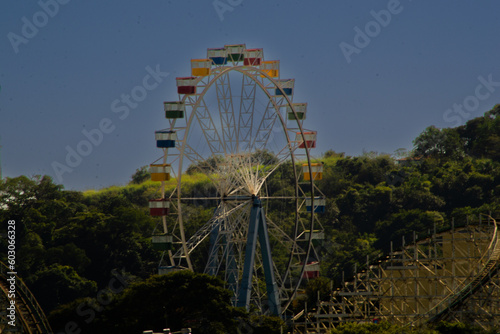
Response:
[0,0,500,190]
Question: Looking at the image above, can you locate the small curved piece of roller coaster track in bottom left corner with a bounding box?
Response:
[0,262,53,334]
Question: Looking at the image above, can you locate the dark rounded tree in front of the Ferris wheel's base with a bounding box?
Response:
[80,271,248,334]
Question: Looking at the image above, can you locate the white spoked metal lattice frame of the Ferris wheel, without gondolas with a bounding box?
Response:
[152,46,321,312]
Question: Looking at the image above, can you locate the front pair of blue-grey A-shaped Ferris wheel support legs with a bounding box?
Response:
[236,197,281,315]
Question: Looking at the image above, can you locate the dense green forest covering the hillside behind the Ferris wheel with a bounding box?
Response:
[0,105,500,333]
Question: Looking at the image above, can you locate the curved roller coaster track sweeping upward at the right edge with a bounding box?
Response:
[428,219,500,323]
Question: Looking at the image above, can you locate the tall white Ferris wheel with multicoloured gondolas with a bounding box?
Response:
[149,44,325,315]
